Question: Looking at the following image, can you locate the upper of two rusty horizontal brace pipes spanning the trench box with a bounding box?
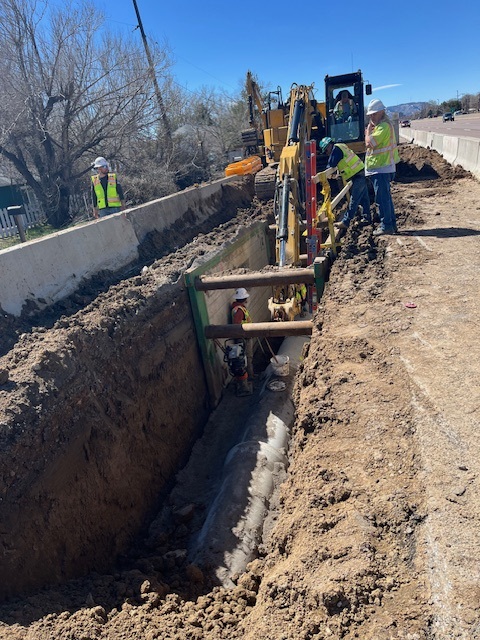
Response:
[195,268,315,291]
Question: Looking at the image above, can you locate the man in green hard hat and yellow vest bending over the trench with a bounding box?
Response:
[319,137,372,229]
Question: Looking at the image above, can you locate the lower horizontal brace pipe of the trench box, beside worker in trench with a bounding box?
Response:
[205,320,313,339]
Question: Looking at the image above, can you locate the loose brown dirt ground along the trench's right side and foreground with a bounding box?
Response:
[0,145,480,640]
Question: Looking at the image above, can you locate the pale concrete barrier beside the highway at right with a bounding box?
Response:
[400,129,480,180]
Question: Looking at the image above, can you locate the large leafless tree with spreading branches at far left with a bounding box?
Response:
[0,0,172,227]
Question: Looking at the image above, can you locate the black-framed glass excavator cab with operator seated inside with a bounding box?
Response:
[325,71,372,153]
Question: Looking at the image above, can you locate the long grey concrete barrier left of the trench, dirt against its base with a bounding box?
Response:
[0,176,242,316]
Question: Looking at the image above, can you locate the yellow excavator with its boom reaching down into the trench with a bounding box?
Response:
[228,71,371,320]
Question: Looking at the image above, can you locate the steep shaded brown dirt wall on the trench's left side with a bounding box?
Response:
[0,176,266,599]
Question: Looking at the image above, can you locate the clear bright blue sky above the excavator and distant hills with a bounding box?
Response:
[107,0,480,106]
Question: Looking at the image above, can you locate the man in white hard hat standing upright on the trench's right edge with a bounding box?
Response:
[365,99,400,236]
